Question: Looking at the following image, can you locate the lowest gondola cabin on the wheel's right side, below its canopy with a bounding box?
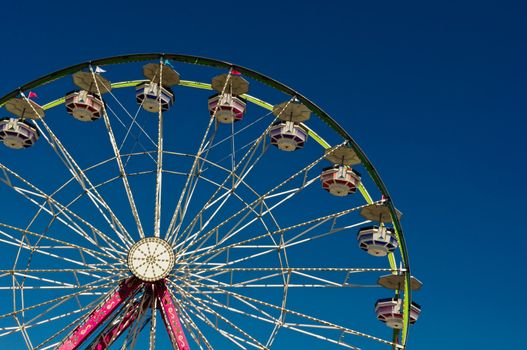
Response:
[375,298,421,329]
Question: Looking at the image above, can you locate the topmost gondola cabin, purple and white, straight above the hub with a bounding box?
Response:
[135,82,174,113]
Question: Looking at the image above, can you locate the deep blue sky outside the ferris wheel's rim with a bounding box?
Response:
[0,0,527,349]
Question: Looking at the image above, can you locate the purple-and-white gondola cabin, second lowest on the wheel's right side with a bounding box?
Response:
[357,226,399,256]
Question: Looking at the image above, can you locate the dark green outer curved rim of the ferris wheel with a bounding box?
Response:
[0,53,411,346]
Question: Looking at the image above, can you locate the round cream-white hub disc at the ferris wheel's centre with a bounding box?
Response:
[128,237,175,282]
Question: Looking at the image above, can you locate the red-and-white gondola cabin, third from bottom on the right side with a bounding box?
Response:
[320,165,360,197]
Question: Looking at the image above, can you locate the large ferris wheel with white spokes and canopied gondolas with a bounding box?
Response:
[0,53,421,350]
